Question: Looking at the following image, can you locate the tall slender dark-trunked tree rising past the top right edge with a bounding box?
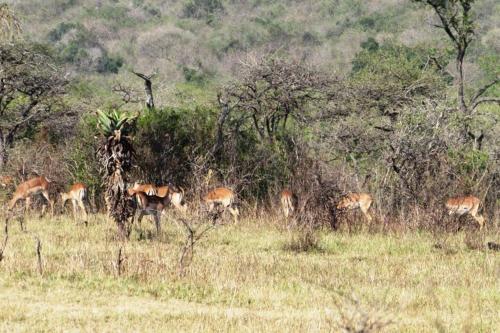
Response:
[413,0,500,145]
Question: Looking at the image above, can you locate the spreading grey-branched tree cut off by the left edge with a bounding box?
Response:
[0,43,67,168]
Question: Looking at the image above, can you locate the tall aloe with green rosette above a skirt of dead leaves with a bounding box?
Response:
[97,110,137,237]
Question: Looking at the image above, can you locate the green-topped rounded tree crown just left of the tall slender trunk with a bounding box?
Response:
[348,43,446,122]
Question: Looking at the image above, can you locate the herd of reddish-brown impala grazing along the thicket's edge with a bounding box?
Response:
[0,176,485,232]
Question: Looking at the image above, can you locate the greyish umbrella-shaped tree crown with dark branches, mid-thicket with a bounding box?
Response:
[219,56,330,142]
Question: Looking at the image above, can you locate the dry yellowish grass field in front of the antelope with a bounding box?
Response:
[0,211,500,332]
